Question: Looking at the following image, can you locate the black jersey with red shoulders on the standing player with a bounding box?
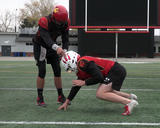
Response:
[34,14,69,49]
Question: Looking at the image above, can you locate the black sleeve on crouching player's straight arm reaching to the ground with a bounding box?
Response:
[68,86,81,101]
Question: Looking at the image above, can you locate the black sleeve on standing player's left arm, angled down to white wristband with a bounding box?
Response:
[39,27,56,50]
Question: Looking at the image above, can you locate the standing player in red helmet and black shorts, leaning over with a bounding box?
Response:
[33,5,69,106]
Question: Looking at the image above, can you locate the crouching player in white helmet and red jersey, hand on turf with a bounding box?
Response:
[58,51,138,115]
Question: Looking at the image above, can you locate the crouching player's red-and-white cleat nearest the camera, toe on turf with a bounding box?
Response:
[122,100,138,116]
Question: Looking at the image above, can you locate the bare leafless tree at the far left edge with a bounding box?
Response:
[0,10,14,32]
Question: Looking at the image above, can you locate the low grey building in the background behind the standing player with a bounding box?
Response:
[0,28,78,56]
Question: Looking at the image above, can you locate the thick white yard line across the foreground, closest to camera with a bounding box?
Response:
[0,121,160,126]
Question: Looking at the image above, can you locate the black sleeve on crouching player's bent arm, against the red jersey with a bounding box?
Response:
[85,61,104,86]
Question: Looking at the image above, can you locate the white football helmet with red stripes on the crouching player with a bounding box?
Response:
[61,51,80,72]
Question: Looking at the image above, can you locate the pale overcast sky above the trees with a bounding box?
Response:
[0,0,69,13]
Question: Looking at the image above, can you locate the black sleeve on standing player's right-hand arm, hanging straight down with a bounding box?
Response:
[62,30,69,50]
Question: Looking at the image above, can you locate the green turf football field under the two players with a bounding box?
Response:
[0,61,160,128]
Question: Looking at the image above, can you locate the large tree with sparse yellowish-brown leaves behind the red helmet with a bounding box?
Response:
[20,0,55,26]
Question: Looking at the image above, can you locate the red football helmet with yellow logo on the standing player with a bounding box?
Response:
[53,5,68,25]
